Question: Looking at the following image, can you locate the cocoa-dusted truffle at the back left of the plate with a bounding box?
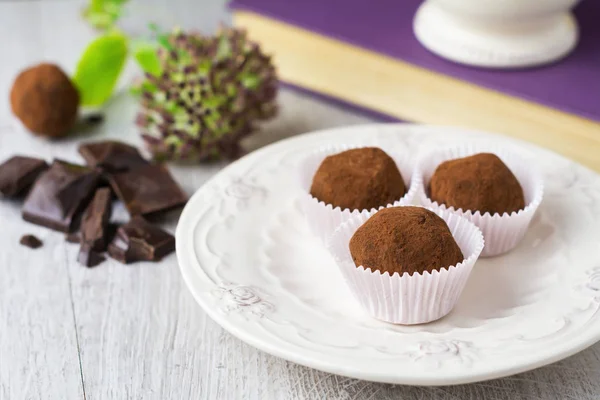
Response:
[310,147,406,210]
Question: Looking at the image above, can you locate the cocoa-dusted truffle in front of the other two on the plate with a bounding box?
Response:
[350,207,464,275]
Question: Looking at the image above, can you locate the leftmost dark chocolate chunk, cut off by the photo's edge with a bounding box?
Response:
[0,156,48,197]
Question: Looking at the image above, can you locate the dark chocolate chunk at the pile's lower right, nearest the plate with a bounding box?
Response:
[108,216,175,264]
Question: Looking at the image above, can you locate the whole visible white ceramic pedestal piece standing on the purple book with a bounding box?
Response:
[414,0,578,68]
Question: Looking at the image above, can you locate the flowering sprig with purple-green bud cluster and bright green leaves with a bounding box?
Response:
[73,11,278,161]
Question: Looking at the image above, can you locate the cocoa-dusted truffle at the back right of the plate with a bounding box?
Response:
[429,153,525,214]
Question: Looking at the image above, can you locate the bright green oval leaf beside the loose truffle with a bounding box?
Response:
[73,32,127,106]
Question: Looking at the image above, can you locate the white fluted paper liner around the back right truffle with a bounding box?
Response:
[415,143,544,257]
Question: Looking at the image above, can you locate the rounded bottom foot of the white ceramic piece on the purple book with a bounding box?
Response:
[413,1,579,68]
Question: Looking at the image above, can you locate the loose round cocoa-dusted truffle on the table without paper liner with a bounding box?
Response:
[10,64,79,137]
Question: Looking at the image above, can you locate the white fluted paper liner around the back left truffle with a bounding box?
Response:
[299,144,418,245]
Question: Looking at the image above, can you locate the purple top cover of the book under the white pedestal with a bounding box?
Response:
[231,0,600,121]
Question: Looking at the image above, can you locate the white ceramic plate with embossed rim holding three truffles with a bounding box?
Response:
[177,125,600,385]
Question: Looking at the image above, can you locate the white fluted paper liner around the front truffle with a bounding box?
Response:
[329,206,484,325]
